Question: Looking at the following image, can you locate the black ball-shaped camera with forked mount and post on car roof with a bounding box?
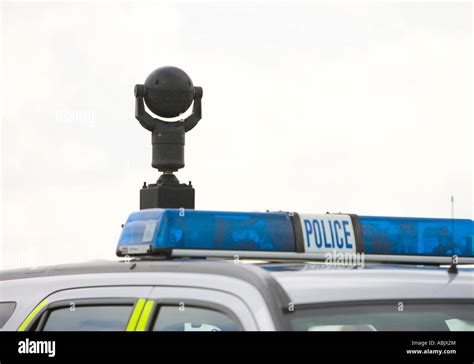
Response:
[135,67,203,210]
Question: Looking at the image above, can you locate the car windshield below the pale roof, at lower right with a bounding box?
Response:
[290,301,474,331]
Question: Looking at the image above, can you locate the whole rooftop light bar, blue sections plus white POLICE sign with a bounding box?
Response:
[117,209,474,262]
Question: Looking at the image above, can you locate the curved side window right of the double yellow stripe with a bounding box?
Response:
[152,305,241,331]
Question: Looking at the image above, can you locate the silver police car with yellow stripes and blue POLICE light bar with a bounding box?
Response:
[0,209,474,331]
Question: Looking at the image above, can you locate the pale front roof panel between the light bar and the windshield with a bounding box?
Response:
[266,264,474,304]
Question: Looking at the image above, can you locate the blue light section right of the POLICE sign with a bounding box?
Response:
[360,216,474,257]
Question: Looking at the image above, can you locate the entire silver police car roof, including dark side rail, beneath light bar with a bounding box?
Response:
[0,259,474,307]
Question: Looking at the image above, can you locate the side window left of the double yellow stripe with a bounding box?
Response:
[38,304,133,331]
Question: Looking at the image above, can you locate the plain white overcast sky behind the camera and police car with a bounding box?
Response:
[0,2,473,268]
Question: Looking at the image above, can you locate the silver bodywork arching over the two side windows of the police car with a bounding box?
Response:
[0,272,275,330]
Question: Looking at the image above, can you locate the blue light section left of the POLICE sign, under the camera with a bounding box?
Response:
[117,209,295,255]
